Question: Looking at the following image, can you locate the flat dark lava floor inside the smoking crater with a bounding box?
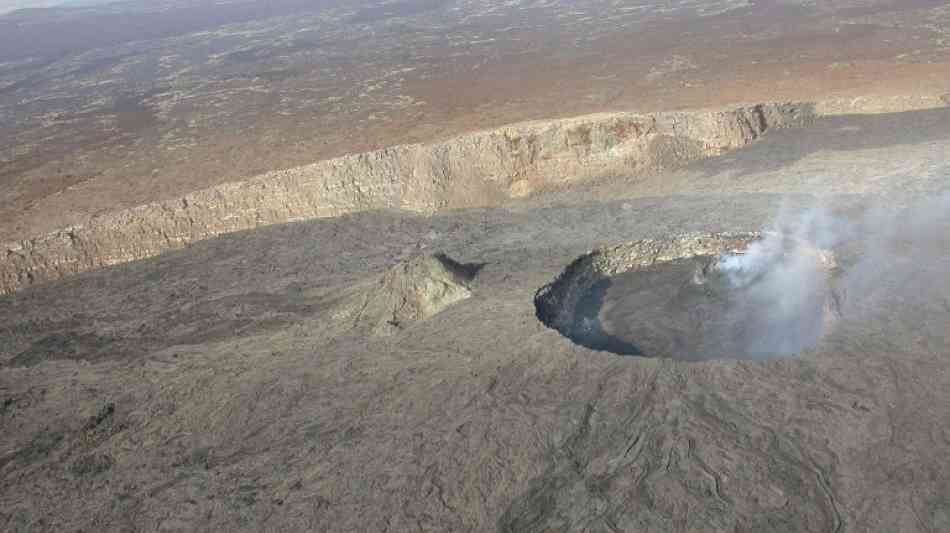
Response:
[570,256,830,360]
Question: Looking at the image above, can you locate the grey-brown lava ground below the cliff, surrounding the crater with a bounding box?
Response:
[0,106,950,532]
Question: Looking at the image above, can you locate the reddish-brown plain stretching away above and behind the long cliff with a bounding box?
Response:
[0,0,950,242]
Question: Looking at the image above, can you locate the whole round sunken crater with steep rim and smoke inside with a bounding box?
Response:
[535,233,840,361]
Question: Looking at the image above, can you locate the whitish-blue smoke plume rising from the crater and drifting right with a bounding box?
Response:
[715,194,950,357]
